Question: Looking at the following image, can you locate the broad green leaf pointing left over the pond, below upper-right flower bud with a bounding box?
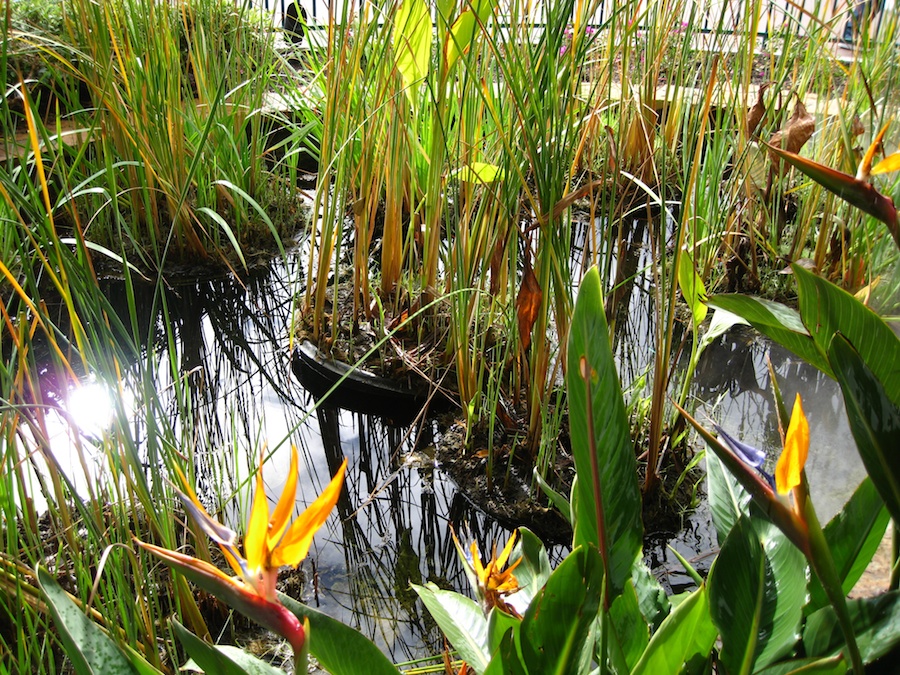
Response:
[709,295,831,375]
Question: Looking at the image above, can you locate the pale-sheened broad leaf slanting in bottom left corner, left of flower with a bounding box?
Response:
[38,568,137,675]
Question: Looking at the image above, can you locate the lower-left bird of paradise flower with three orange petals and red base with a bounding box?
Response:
[136,448,347,672]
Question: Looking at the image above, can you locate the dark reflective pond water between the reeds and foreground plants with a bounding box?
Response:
[33,236,865,662]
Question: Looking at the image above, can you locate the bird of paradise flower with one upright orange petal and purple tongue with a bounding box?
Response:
[676,394,864,675]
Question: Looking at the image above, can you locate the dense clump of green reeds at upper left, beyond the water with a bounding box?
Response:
[7,0,308,268]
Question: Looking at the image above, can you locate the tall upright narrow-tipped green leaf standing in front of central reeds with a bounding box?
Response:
[566,267,643,601]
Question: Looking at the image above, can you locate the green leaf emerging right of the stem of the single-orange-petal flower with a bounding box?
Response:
[804,478,890,614]
